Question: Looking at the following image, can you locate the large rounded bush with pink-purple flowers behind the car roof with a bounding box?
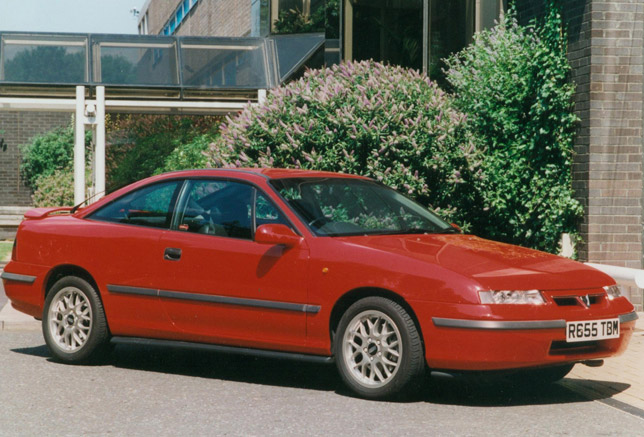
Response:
[208,61,481,227]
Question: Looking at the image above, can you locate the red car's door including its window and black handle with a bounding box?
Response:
[160,179,315,351]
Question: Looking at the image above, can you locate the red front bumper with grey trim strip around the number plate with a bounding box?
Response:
[413,298,637,370]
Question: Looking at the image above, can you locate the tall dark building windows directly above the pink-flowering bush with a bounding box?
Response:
[341,0,505,80]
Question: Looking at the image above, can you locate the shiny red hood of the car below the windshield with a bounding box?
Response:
[340,234,614,290]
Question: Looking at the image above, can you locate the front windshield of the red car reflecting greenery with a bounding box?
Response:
[271,178,455,236]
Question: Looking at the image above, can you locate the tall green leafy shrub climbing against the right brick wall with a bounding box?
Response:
[445,1,583,252]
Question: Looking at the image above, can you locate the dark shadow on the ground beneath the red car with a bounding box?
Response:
[11,344,630,407]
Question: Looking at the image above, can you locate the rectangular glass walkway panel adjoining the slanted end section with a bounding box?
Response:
[181,38,270,89]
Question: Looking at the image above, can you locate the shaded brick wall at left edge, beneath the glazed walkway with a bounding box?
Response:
[0,111,71,206]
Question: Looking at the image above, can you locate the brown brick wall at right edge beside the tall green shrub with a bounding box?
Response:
[585,0,644,310]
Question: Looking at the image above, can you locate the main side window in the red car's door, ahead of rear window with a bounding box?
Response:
[177,180,254,239]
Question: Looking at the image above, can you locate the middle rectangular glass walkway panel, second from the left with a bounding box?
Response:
[92,36,179,87]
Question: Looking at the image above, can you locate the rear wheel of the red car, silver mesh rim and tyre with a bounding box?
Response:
[42,276,110,364]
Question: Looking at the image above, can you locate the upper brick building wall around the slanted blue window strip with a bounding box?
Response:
[141,0,251,36]
